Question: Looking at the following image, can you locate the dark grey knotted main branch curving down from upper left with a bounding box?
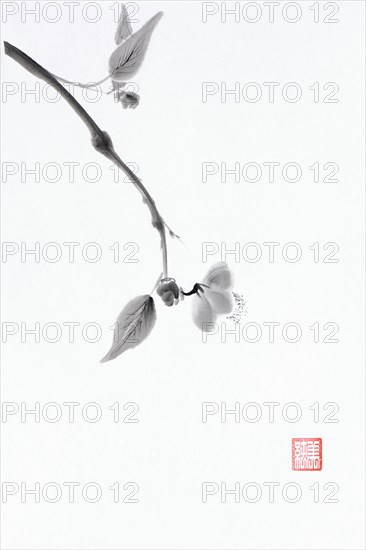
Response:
[4,42,168,277]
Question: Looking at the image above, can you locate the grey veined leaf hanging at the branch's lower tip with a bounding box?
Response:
[100,294,156,363]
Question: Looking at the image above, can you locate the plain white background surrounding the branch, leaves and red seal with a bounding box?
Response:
[2,1,364,550]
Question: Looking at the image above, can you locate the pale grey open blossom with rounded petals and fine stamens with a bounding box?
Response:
[193,262,233,331]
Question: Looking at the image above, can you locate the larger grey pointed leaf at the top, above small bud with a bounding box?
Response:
[109,11,163,82]
